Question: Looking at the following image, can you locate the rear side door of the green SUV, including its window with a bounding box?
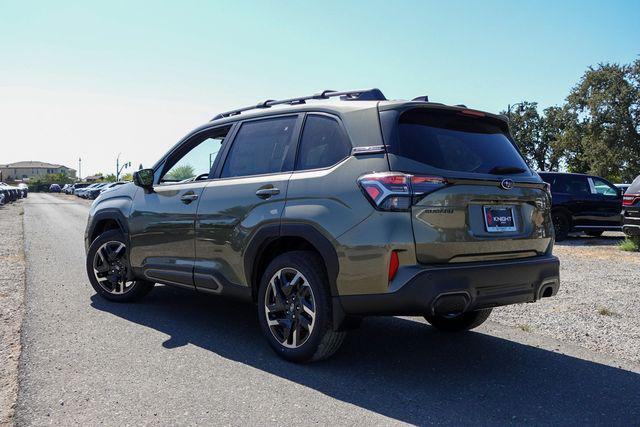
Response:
[194,114,301,294]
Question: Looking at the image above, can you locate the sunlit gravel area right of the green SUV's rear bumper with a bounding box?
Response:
[491,232,640,363]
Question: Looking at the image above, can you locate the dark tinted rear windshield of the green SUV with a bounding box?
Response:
[390,109,529,174]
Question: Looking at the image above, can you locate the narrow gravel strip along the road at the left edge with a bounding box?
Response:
[0,201,25,425]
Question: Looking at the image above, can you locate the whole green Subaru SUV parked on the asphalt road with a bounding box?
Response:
[85,89,559,362]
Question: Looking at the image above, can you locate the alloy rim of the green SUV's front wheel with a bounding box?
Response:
[93,241,135,295]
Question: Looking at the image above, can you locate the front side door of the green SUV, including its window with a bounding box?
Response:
[129,126,230,288]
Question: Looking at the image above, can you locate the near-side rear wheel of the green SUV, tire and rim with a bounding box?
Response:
[258,251,345,362]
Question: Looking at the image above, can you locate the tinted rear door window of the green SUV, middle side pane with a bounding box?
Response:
[222,116,298,178]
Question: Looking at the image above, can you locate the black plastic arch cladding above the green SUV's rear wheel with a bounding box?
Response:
[244,224,339,301]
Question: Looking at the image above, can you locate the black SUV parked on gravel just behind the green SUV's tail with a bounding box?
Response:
[539,172,622,241]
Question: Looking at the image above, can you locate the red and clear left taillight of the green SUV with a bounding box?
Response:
[358,172,447,211]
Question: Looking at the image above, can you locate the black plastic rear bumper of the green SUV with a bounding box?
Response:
[337,256,560,315]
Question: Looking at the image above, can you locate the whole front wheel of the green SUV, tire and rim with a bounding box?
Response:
[86,230,154,302]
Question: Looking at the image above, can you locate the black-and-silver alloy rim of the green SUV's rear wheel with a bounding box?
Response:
[264,268,316,348]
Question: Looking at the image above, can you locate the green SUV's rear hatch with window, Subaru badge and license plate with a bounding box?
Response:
[380,106,552,263]
